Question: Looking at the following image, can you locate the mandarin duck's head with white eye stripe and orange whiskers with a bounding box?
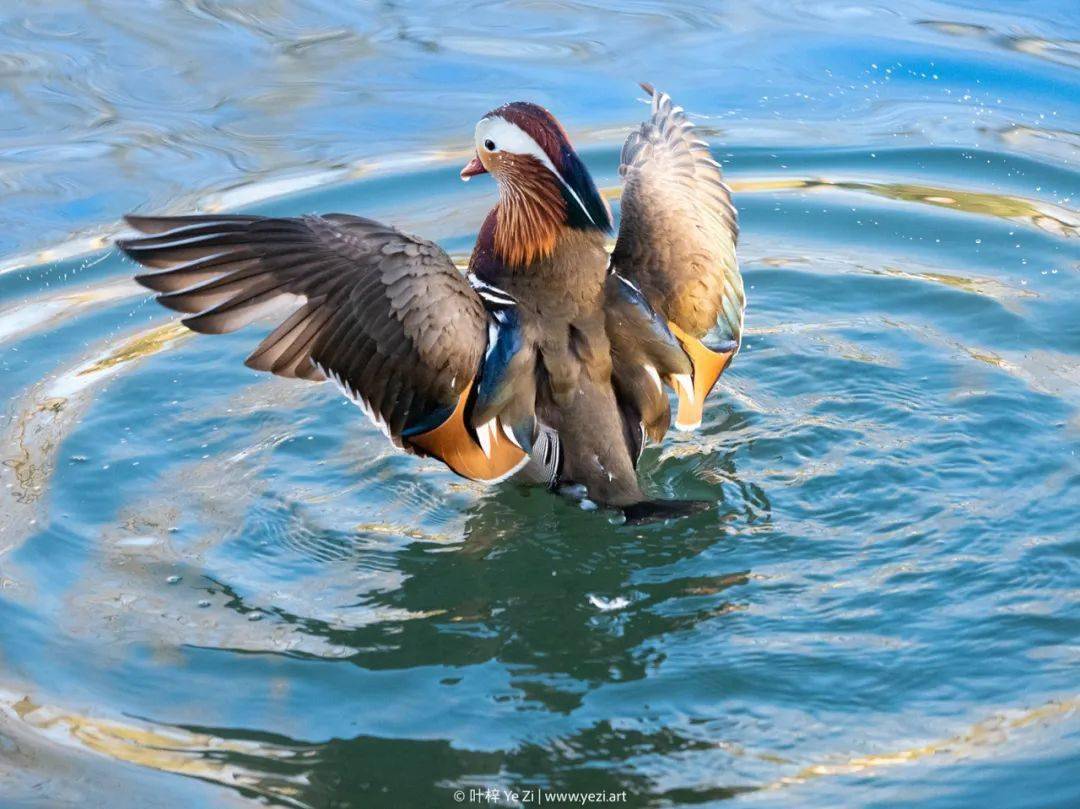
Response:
[461,102,611,265]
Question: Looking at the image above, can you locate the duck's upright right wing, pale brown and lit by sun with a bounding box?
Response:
[611,84,745,429]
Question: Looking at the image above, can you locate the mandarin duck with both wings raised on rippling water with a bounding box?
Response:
[118,84,745,522]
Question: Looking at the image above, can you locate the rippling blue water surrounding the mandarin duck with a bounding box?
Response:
[0,0,1080,809]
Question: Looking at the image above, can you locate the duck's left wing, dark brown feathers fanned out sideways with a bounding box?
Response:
[119,214,528,481]
